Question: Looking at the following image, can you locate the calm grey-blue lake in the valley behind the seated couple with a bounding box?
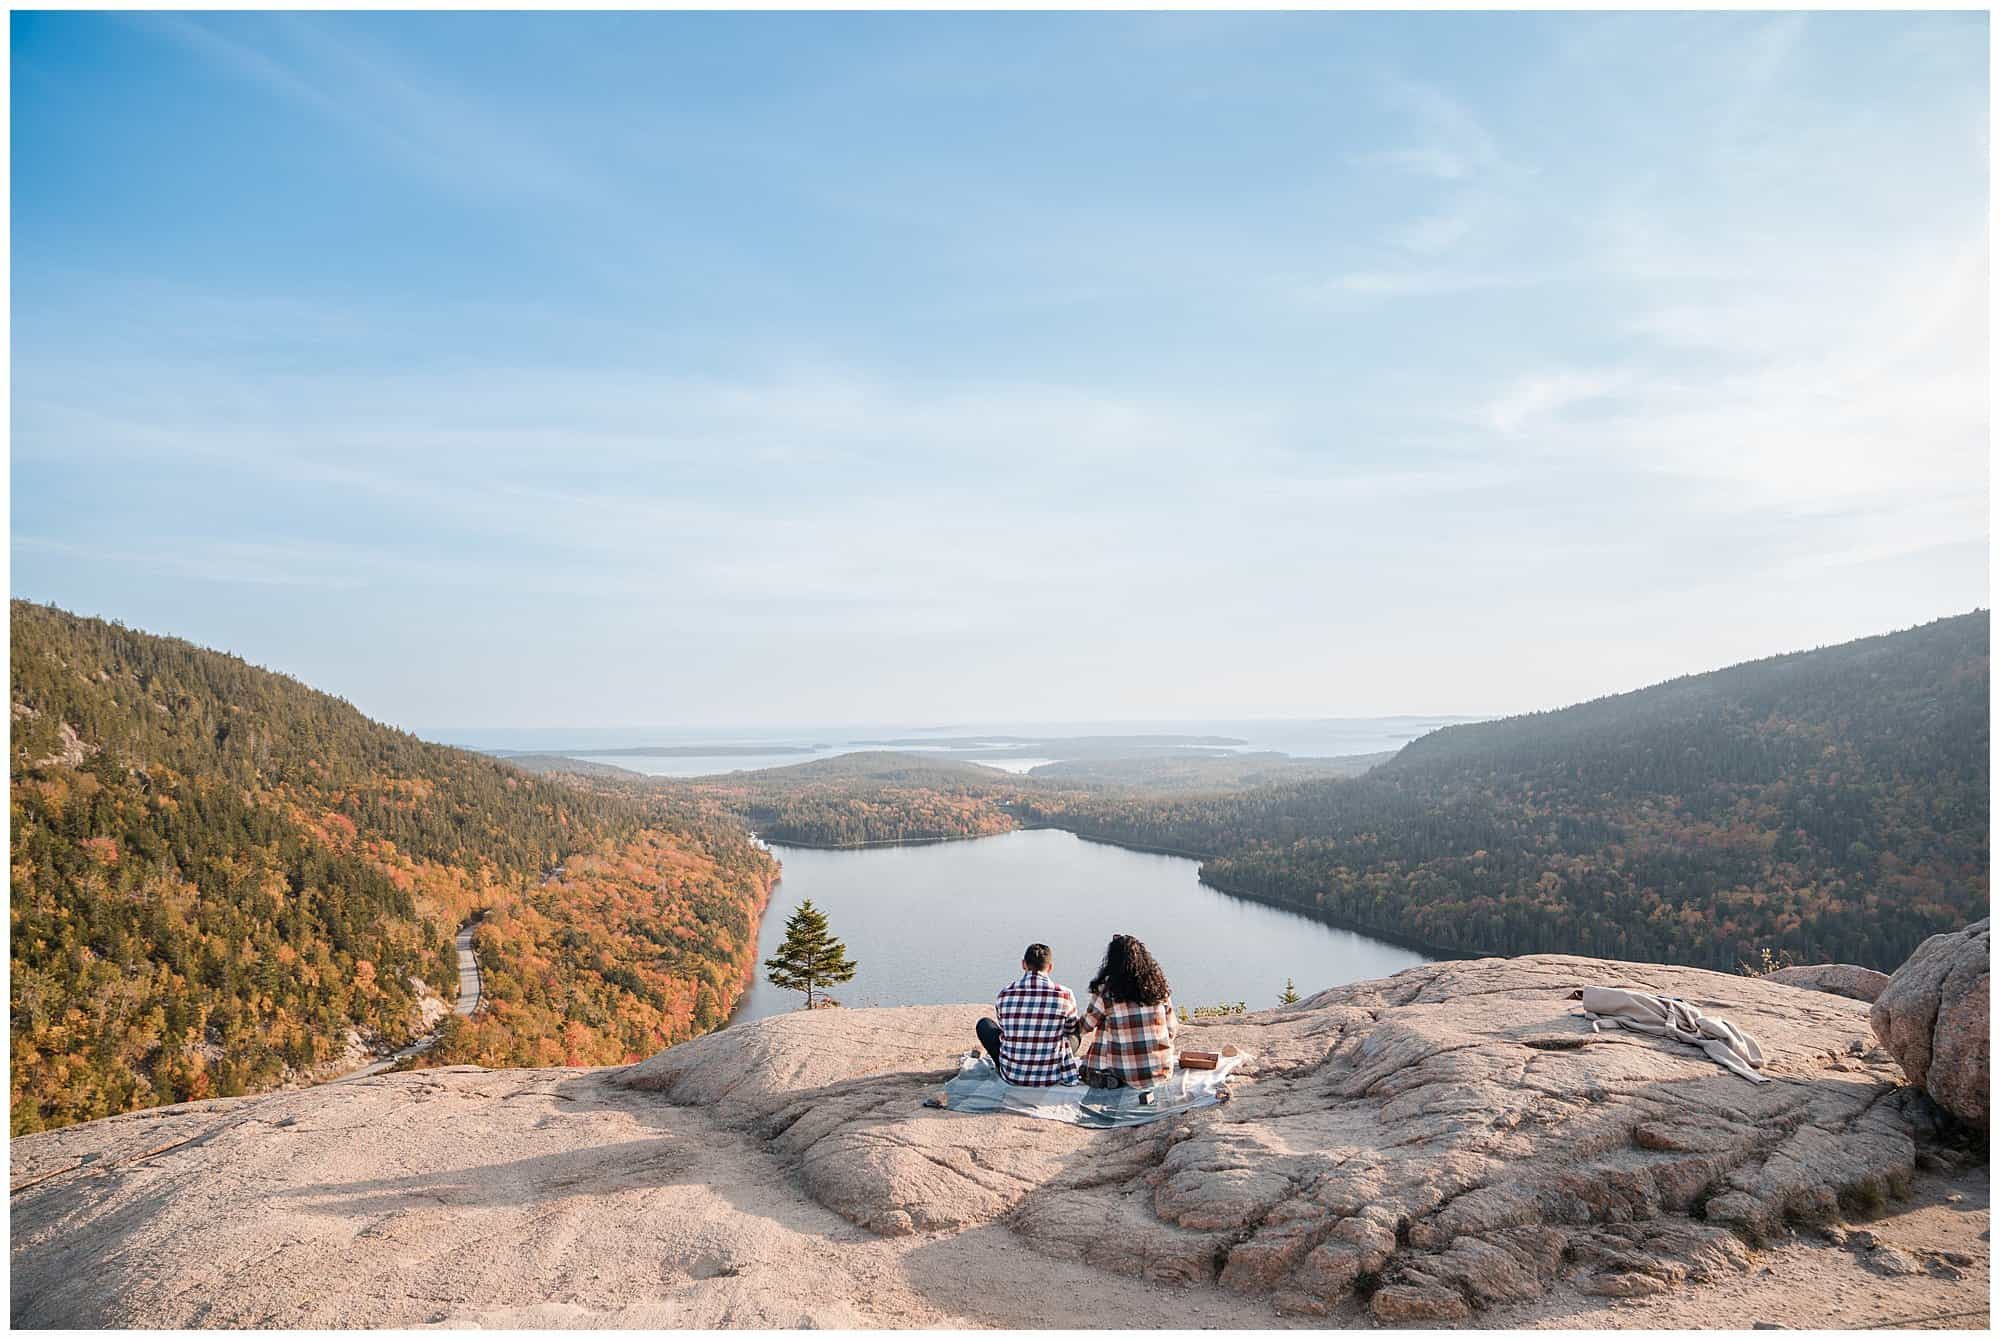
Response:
[736,828,1426,1020]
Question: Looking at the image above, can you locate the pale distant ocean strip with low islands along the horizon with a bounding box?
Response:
[418,716,1486,776]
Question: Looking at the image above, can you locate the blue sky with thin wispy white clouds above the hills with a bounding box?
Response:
[10,12,1990,730]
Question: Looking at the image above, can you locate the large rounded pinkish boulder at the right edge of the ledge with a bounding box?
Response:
[1868,920,1992,1130]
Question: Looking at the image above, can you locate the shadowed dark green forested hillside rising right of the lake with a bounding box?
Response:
[1014,612,1990,968]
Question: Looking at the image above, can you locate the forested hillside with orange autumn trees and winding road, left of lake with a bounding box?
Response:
[10,602,774,1132]
